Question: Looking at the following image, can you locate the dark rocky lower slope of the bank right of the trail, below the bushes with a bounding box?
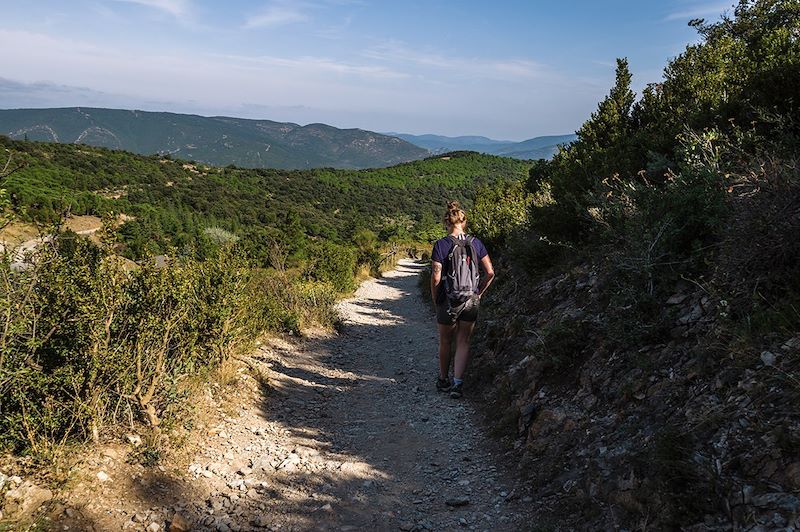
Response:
[473,258,800,531]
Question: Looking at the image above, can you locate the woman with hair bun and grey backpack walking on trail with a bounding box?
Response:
[431,201,494,399]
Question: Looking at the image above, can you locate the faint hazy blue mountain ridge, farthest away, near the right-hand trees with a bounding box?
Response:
[386,133,578,159]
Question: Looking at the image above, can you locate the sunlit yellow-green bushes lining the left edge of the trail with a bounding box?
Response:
[0,234,335,451]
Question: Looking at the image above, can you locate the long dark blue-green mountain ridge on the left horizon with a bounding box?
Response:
[0,107,430,169]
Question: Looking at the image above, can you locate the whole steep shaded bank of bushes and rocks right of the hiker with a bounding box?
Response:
[474,0,800,530]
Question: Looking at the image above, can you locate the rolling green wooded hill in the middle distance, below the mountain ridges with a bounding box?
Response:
[0,136,529,259]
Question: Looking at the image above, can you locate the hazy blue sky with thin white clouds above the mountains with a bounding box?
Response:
[0,0,734,140]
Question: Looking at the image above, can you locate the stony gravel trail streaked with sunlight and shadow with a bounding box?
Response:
[57,261,532,531]
